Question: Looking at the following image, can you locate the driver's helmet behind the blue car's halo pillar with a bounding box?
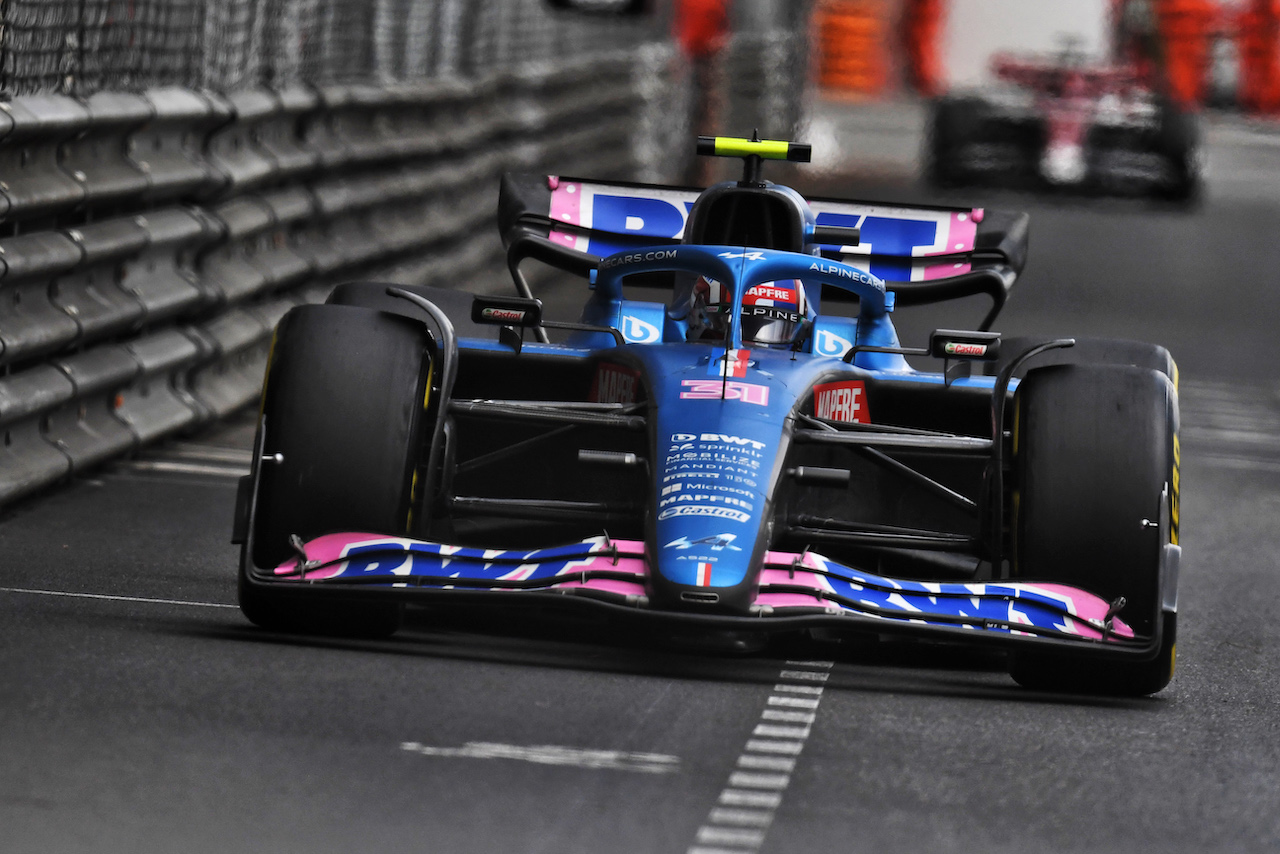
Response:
[689,277,809,347]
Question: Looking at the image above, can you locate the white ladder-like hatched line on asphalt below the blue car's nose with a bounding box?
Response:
[687,661,835,854]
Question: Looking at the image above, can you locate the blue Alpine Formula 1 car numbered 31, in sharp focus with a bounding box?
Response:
[236,138,1180,694]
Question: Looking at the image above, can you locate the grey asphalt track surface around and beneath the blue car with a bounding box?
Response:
[0,113,1280,854]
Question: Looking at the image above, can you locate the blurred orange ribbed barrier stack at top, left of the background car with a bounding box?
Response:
[817,0,890,96]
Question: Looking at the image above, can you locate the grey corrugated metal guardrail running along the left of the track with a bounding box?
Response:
[0,46,660,506]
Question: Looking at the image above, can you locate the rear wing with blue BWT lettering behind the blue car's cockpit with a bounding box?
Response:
[498,173,1028,329]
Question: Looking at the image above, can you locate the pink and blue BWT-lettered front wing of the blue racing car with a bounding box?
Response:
[241,533,1158,657]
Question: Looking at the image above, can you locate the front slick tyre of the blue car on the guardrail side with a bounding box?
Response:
[239,305,431,636]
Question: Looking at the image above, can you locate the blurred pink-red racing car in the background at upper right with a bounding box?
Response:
[925,54,1201,201]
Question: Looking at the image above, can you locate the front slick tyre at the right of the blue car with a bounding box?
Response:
[1010,365,1178,697]
